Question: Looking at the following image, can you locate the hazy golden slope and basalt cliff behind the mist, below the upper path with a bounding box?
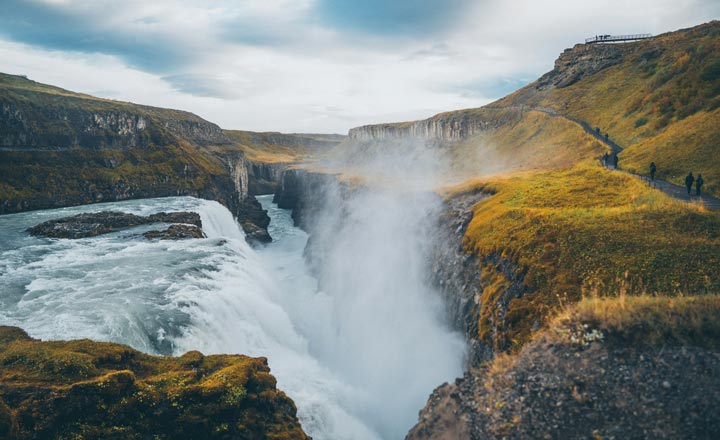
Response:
[332,108,610,181]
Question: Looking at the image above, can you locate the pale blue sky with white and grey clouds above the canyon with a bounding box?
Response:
[0,0,720,134]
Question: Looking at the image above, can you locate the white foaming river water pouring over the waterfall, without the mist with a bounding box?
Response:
[0,197,380,440]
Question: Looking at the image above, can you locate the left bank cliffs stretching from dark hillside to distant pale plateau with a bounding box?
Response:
[0,74,334,242]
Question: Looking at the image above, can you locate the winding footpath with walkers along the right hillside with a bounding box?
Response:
[488,105,720,210]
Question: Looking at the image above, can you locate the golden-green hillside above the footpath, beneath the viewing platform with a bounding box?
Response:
[493,21,720,195]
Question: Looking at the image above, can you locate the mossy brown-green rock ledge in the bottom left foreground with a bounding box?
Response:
[0,327,309,440]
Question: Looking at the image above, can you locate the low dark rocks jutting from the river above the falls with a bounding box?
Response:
[27,211,202,239]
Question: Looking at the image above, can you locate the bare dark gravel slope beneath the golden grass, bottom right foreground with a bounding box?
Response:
[406,332,720,440]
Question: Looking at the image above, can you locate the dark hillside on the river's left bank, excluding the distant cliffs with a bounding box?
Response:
[0,74,238,213]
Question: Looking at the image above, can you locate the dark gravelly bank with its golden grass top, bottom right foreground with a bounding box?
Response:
[406,297,720,440]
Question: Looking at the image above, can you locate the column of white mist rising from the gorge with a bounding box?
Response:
[296,136,464,439]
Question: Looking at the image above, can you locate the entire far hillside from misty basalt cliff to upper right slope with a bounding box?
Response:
[342,21,720,195]
